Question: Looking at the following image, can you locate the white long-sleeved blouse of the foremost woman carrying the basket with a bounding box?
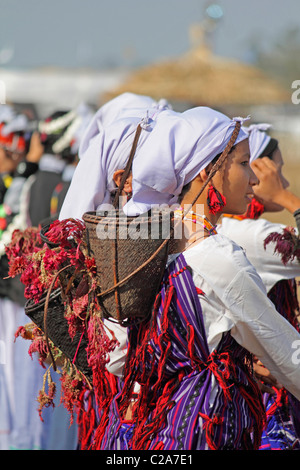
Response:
[107,234,300,399]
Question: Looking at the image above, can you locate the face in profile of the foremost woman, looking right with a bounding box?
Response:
[213,139,258,214]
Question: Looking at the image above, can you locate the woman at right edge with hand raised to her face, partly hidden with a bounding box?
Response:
[219,124,300,450]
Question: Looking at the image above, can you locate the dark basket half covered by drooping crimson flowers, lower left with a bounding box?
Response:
[25,289,92,382]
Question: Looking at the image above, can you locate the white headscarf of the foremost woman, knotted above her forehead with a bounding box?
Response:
[124,107,248,215]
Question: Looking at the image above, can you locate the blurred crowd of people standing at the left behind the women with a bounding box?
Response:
[0,103,93,450]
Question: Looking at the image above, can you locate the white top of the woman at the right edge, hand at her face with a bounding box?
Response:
[217,217,300,292]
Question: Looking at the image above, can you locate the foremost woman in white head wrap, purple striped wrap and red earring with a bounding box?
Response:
[75,95,300,450]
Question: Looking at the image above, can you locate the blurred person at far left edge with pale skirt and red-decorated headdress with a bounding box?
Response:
[0,105,42,449]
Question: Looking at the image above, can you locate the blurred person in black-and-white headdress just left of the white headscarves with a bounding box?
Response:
[28,104,93,226]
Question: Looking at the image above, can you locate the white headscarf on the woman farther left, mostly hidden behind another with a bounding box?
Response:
[59,93,169,220]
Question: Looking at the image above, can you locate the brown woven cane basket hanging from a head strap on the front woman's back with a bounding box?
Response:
[83,210,173,324]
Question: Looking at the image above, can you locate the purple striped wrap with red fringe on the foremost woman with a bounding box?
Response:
[98,255,264,450]
